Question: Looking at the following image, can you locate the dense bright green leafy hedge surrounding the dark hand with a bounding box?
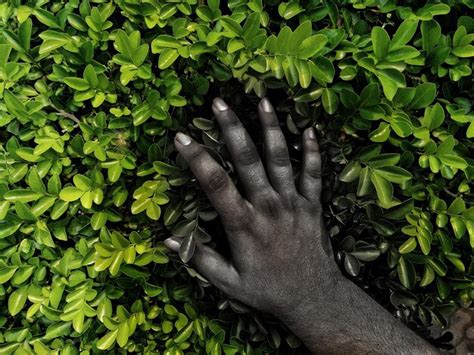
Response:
[0,0,474,354]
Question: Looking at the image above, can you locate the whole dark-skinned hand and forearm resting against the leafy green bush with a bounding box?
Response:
[165,98,435,354]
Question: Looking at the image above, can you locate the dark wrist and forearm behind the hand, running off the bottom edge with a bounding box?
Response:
[280,274,438,354]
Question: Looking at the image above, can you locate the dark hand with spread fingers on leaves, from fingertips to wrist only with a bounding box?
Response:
[165,98,339,314]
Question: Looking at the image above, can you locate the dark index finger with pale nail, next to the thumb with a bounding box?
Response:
[175,133,248,230]
